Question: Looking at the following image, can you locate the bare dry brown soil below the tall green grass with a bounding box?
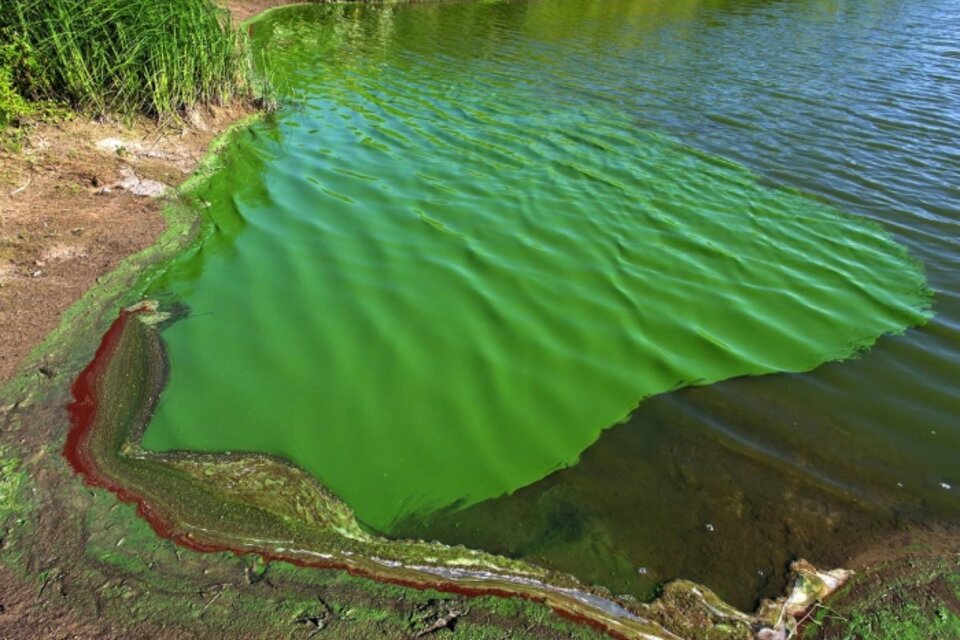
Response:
[0,106,250,385]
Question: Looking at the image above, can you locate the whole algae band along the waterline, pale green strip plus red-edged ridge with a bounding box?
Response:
[0,2,900,638]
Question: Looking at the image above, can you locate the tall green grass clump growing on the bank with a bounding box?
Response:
[0,0,248,117]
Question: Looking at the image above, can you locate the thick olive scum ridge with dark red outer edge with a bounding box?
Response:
[65,305,792,639]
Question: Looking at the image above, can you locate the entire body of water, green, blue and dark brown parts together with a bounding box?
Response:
[137,0,960,608]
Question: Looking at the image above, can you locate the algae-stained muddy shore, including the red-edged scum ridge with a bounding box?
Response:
[0,1,951,638]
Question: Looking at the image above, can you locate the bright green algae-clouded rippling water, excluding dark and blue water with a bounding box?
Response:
[144,2,928,530]
